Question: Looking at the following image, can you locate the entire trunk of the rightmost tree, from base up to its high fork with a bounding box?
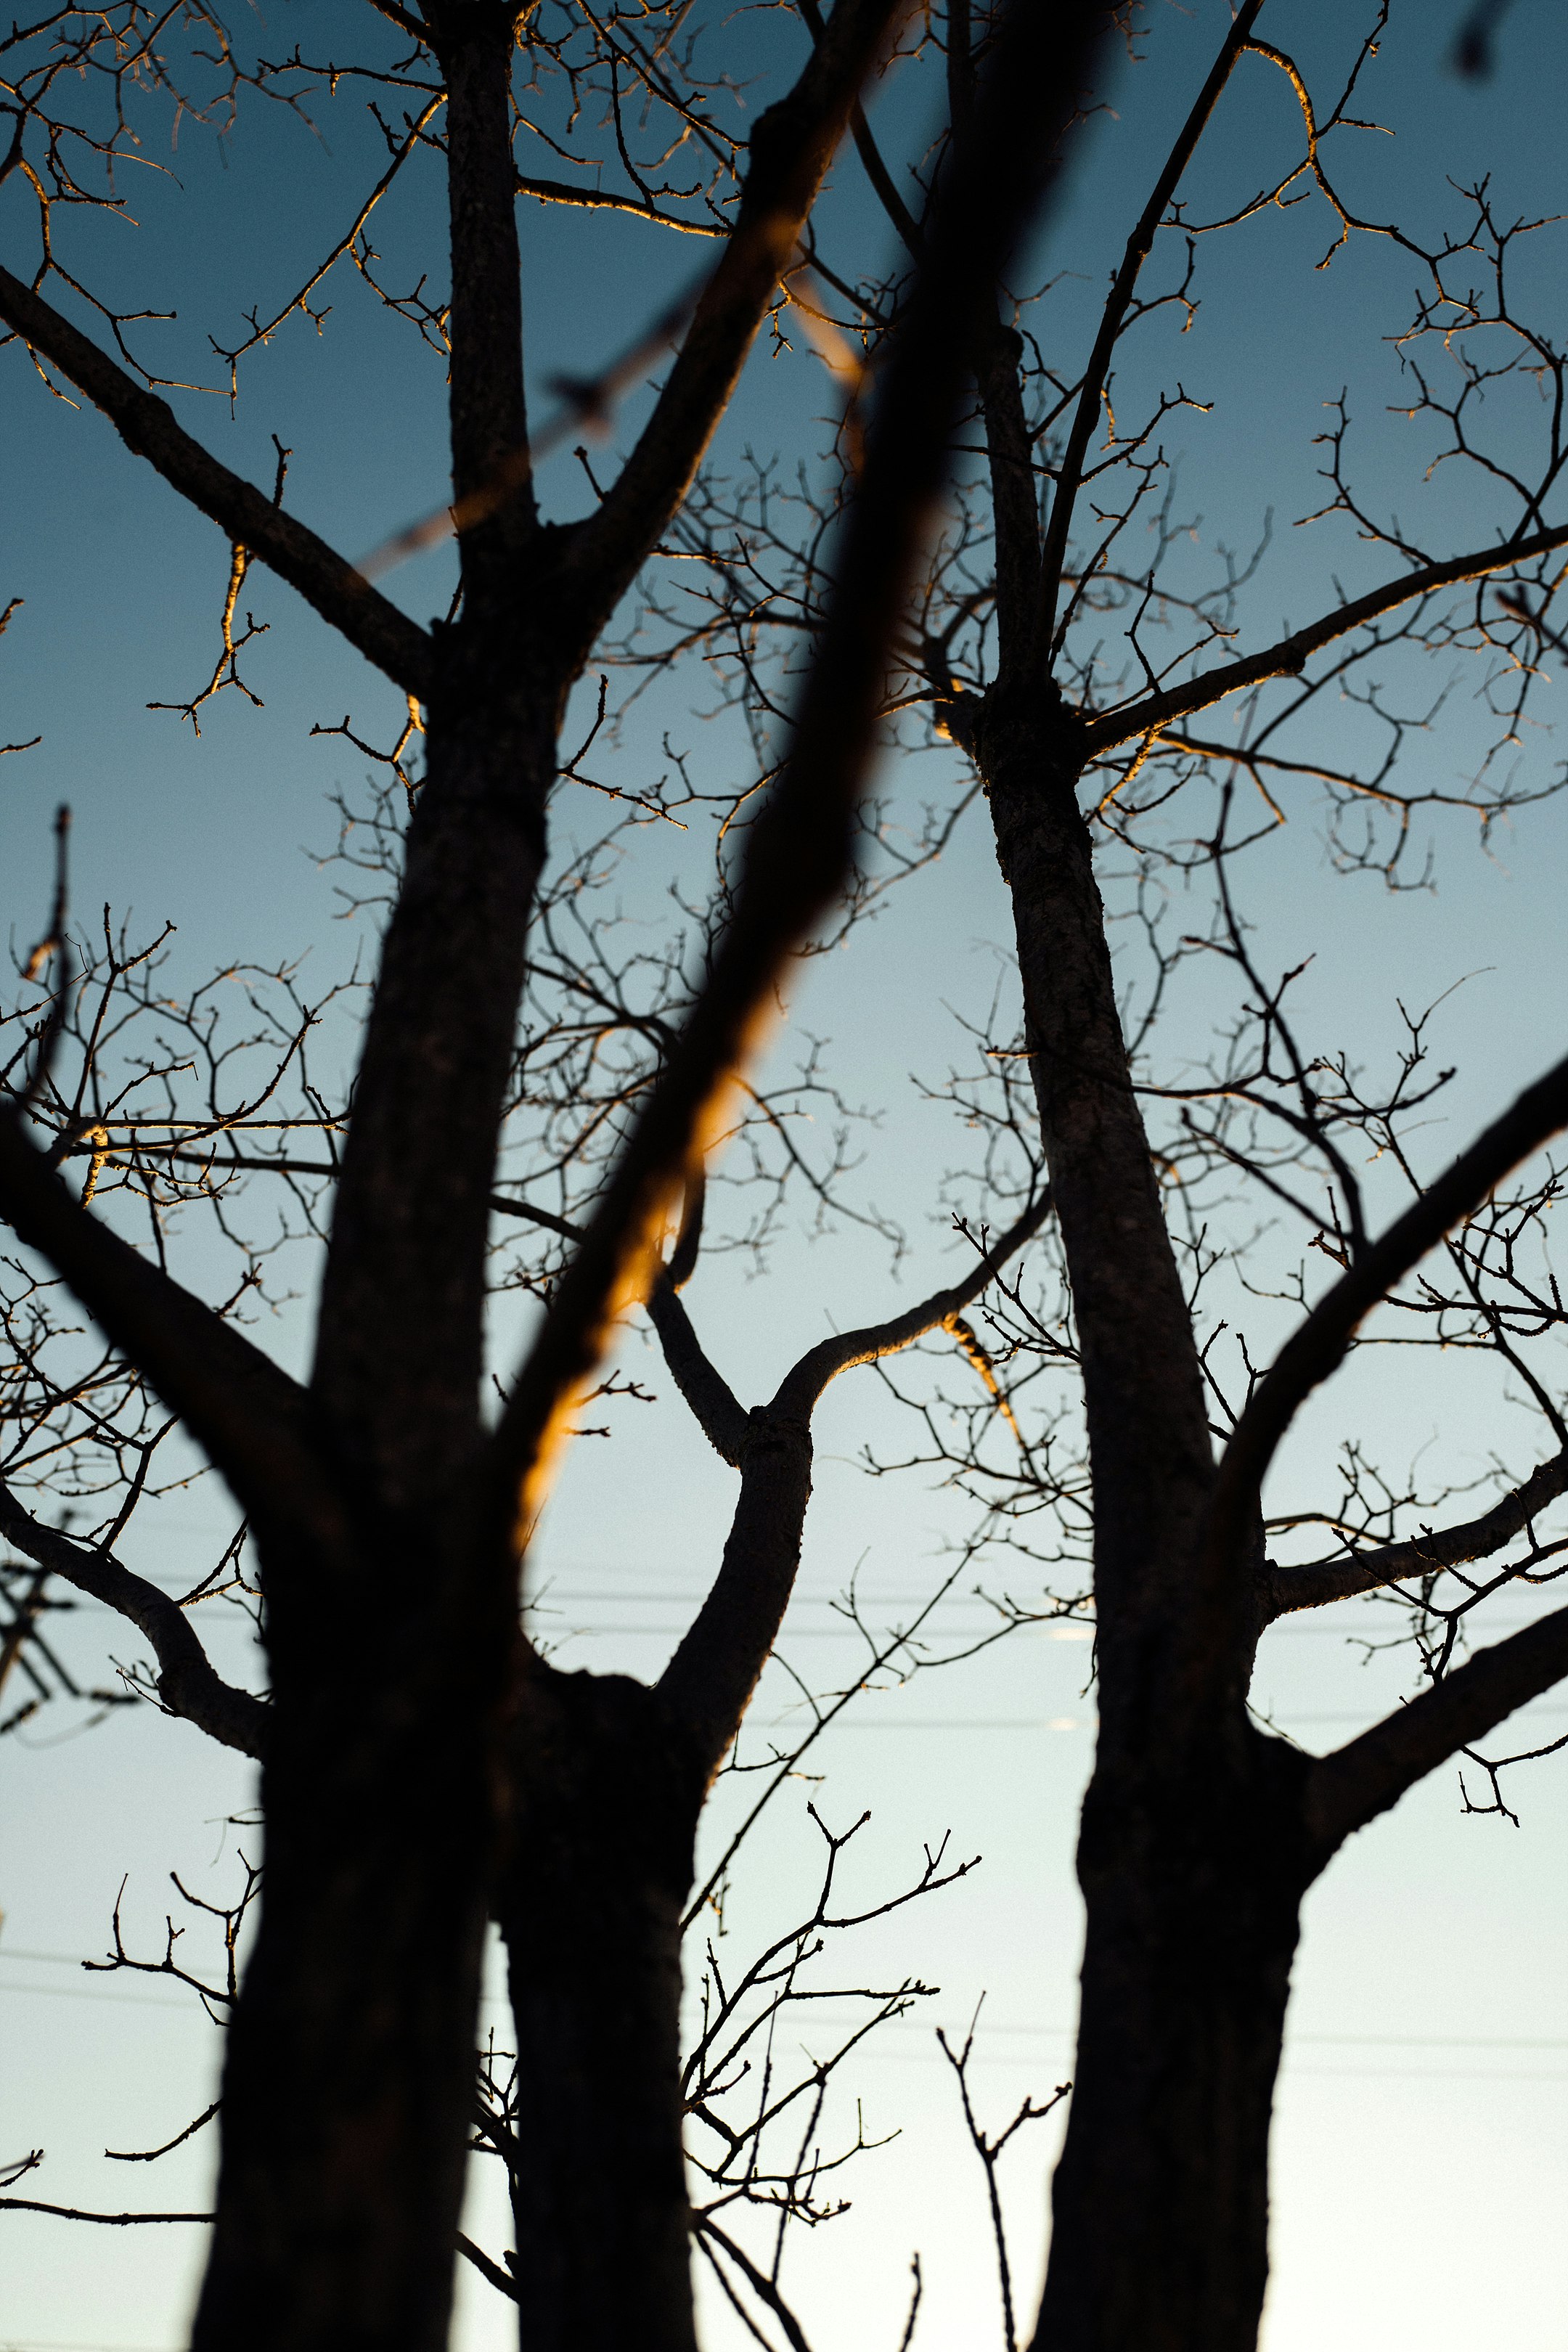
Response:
[976,689,1312,2352]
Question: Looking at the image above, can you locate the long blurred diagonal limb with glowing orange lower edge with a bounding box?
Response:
[489,0,1105,1540]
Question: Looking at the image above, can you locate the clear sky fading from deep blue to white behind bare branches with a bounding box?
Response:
[0,14,1568,2352]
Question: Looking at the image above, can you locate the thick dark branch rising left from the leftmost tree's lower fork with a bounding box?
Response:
[0,1106,348,1550]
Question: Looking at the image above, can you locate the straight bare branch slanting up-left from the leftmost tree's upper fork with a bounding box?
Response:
[0,268,435,701]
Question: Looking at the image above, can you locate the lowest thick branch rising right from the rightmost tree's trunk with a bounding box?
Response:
[1304,1609,1568,1870]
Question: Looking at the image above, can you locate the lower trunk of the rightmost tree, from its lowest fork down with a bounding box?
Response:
[1034,1726,1312,2352]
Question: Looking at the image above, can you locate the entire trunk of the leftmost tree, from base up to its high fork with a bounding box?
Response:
[195,682,557,2352]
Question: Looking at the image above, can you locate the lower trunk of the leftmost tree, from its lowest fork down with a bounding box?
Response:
[195,1529,505,2352]
